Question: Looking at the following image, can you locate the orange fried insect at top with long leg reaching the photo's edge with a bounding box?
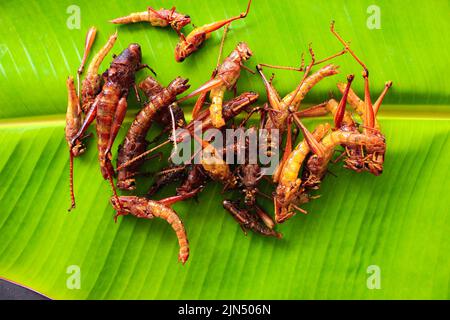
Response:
[175,0,252,62]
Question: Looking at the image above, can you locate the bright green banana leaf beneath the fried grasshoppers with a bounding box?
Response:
[0,0,450,299]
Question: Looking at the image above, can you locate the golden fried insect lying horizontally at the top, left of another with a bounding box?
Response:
[109,7,191,33]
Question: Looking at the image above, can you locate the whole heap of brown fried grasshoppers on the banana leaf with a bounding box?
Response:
[66,0,392,264]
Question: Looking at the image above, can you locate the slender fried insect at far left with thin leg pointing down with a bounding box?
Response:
[65,77,85,211]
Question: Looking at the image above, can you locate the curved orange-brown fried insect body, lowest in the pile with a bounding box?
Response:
[111,196,189,264]
